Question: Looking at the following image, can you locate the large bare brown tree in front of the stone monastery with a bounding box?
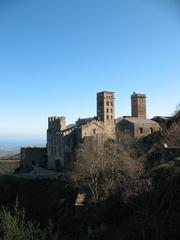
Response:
[72,135,144,201]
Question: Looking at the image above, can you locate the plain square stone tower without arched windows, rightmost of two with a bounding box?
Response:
[131,92,146,118]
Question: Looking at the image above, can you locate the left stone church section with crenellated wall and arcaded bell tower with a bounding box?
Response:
[47,91,115,171]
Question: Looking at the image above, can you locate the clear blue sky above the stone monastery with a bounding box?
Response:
[0,0,180,143]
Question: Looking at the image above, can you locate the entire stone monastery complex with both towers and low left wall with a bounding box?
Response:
[21,91,160,171]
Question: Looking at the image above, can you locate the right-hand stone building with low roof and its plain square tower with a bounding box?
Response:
[116,92,161,138]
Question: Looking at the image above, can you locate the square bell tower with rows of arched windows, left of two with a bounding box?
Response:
[97,91,115,138]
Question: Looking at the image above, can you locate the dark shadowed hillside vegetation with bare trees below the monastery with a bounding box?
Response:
[0,123,180,240]
